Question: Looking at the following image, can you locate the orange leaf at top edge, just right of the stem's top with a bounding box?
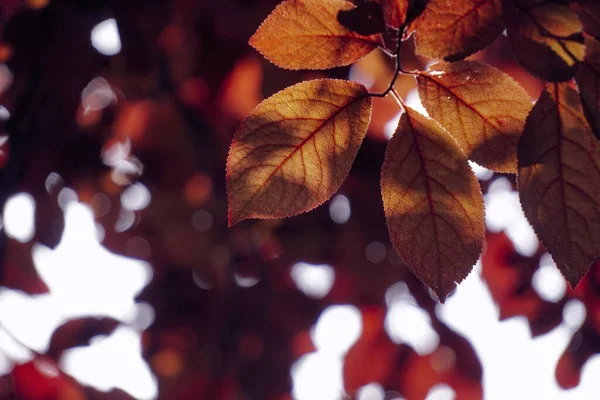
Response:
[412,0,504,61]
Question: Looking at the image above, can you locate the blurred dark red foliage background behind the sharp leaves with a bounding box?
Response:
[0,0,600,400]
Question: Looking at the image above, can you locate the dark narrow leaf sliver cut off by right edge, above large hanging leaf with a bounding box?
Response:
[575,39,600,139]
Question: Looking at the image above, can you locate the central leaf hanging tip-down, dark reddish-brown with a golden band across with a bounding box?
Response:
[381,108,485,302]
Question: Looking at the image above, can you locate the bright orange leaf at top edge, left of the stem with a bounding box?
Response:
[250,0,383,69]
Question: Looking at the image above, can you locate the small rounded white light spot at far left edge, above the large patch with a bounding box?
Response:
[4,193,35,243]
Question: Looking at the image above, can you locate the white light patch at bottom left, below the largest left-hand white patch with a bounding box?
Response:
[60,327,158,400]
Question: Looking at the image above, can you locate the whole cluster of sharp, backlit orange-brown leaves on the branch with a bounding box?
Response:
[227,0,600,301]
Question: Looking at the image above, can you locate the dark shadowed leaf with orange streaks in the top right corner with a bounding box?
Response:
[504,0,585,81]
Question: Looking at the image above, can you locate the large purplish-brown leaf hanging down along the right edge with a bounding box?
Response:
[518,83,600,287]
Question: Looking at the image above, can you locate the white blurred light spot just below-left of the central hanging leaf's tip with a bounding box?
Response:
[385,282,440,355]
